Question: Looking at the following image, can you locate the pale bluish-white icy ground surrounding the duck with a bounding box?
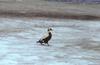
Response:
[0,18,100,65]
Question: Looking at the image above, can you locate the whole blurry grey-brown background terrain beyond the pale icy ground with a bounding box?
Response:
[0,0,100,20]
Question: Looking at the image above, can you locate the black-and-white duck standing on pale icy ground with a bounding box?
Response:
[37,28,53,46]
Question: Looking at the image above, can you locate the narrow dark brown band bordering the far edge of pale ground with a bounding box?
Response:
[0,11,100,20]
